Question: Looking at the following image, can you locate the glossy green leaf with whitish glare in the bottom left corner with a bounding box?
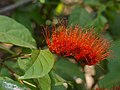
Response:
[0,77,31,90]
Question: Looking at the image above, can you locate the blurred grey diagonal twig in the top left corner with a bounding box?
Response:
[0,0,33,14]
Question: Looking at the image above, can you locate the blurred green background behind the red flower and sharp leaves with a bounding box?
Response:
[0,0,120,90]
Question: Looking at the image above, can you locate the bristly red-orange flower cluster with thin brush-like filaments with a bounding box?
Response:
[46,26,110,65]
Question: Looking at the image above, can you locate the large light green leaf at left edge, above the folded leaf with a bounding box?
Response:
[0,15,36,48]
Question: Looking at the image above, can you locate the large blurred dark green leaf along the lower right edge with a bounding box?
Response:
[99,40,120,88]
